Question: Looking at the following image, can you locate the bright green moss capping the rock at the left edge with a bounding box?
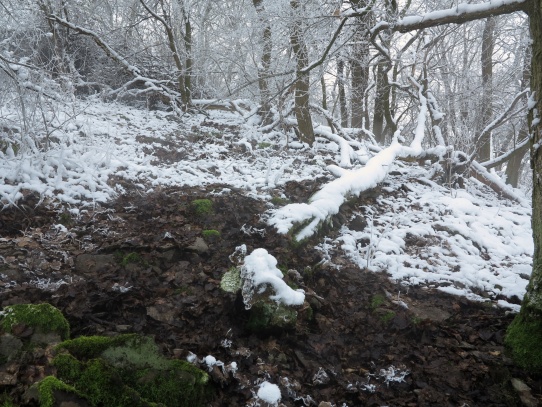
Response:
[0,303,70,339]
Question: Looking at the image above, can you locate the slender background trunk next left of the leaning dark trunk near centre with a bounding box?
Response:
[252,0,273,126]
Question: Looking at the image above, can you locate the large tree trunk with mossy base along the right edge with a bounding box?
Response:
[506,0,542,372]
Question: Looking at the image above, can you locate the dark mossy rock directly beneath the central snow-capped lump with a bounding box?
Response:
[247,300,297,334]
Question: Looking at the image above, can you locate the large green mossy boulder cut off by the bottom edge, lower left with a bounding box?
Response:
[53,334,210,407]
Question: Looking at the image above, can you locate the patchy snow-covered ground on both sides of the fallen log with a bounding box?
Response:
[0,101,533,309]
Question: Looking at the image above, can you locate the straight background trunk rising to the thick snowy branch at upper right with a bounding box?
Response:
[476,17,496,162]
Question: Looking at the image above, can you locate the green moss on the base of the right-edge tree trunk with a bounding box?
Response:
[505,313,542,373]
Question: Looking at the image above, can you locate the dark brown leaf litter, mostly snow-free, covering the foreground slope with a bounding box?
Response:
[0,180,542,407]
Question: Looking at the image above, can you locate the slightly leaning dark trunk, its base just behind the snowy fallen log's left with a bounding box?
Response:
[290,0,314,146]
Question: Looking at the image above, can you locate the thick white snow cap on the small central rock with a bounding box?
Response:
[241,249,305,309]
